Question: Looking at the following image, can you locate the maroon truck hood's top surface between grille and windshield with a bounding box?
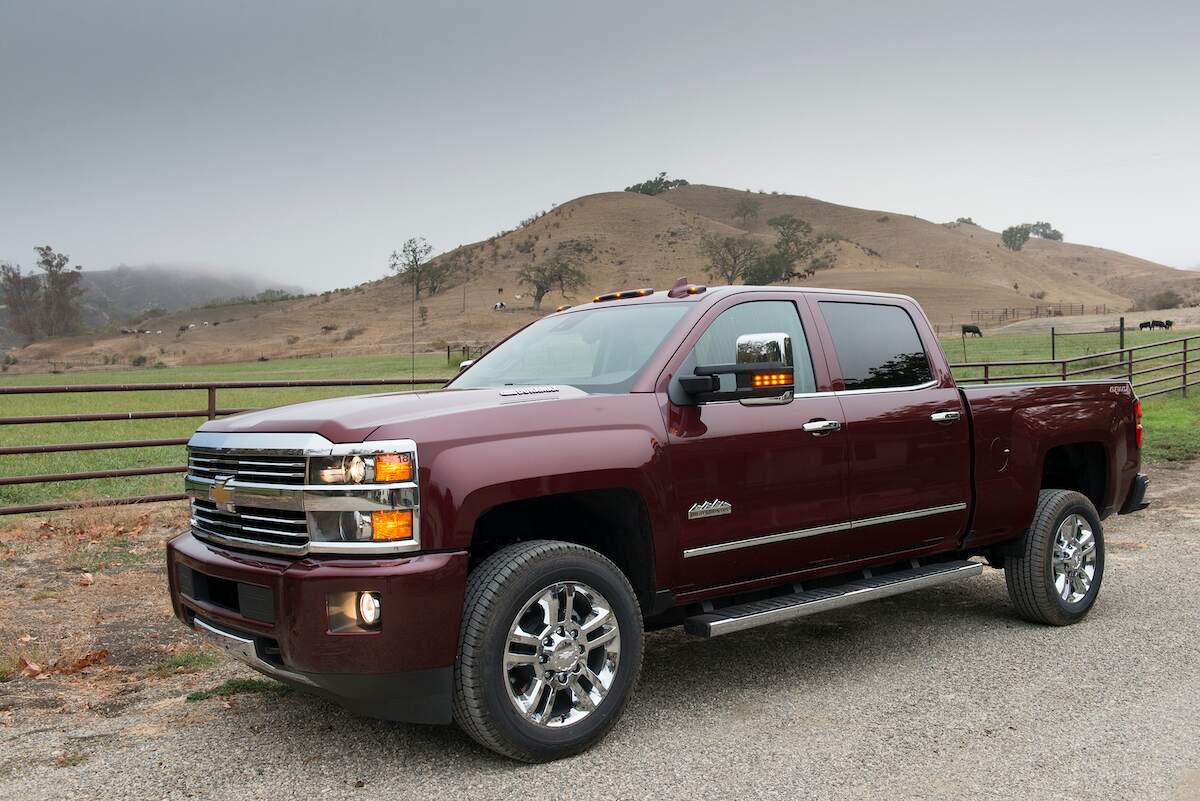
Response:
[199,386,587,442]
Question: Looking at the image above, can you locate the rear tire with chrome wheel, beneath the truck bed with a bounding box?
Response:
[1004,489,1104,626]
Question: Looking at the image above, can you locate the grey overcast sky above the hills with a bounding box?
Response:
[0,0,1200,289]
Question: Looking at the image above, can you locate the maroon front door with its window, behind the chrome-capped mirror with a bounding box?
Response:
[667,293,848,591]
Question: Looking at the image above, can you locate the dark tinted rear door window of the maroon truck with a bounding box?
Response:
[820,301,934,390]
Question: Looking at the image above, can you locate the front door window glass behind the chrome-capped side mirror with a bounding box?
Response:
[685,301,817,395]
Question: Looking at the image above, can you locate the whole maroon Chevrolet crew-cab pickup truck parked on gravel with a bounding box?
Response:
[168,281,1147,761]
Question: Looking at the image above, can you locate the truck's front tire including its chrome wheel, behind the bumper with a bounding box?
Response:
[454,540,642,763]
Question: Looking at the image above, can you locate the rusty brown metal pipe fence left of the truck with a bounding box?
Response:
[0,378,449,516]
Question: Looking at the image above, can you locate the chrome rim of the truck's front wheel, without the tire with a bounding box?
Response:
[503,582,620,727]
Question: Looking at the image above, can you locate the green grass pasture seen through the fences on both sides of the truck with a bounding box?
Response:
[0,332,1200,506]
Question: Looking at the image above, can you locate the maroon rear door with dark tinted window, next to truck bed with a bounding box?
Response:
[809,294,971,556]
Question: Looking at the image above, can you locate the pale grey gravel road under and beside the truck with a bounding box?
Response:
[0,465,1200,801]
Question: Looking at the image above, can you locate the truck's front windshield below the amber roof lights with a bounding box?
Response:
[450,303,691,392]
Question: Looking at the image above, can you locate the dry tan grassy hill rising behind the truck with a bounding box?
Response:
[17,186,1200,363]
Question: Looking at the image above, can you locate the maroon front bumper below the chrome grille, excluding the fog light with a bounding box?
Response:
[167,532,467,723]
